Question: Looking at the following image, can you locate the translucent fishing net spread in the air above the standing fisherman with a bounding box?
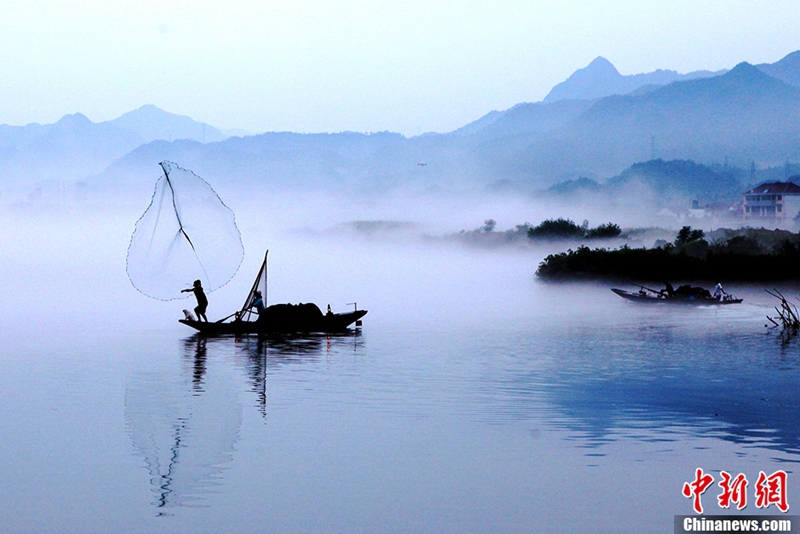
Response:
[127,161,244,300]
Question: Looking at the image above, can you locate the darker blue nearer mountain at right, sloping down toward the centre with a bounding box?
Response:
[473,63,800,187]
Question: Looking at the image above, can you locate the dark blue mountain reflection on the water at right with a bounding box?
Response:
[488,321,800,461]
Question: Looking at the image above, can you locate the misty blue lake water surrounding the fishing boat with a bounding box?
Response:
[0,202,800,533]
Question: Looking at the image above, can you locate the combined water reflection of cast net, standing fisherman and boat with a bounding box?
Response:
[125,331,363,515]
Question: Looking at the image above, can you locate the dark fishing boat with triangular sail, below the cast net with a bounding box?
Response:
[179,255,367,334]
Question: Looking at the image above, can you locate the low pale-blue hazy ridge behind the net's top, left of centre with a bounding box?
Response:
[90,132,465,202]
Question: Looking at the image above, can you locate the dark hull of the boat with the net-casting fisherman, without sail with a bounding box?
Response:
[178,310,367,335]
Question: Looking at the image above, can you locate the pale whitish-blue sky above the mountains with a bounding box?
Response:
[0,0,800,136]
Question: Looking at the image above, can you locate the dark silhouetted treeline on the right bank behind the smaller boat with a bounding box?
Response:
[536,226,800,282]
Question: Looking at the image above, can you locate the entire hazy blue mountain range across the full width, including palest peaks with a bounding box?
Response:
[0,51,800,207]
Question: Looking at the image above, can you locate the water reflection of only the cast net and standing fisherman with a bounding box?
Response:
[125,338,242,515]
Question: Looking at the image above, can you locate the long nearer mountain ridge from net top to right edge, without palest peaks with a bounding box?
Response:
[87,59,800,204]
